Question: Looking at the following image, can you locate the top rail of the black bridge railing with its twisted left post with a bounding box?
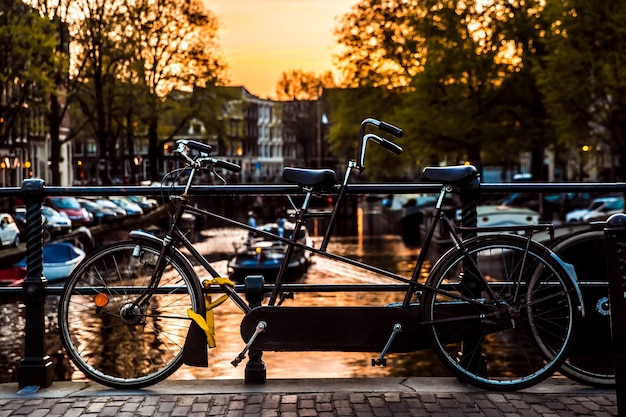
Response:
[0,179,626,388]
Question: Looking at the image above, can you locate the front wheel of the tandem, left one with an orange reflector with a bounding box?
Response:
[59,241,203,389]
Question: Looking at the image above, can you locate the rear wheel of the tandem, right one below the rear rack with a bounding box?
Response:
[422,234,580,391]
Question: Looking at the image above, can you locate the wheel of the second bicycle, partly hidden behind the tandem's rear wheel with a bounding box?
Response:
[552,230,616,388]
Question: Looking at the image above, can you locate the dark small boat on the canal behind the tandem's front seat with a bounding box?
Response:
[228,219,311,282]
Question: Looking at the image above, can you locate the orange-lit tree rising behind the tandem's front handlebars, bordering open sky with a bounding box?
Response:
[129,0,225,181]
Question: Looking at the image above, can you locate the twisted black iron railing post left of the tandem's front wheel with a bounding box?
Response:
[18,179,54,388]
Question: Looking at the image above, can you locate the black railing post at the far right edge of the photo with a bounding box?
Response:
[604,213,626,416]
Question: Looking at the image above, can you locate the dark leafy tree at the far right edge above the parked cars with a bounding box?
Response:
[537,0,626,179]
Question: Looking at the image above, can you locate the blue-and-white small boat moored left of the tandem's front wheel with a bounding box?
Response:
[16,242,85,281]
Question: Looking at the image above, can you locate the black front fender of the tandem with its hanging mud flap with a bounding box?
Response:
[129,230,209,368]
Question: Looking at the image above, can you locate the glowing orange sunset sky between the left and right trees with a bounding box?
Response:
[204,0,358,98]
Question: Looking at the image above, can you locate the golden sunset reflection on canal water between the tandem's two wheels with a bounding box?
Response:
[173,231,449,379]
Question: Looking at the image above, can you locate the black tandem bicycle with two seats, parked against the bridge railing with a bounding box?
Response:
[59,118,583,391]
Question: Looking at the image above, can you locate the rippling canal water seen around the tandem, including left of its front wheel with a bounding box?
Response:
[0,224,449,382]
